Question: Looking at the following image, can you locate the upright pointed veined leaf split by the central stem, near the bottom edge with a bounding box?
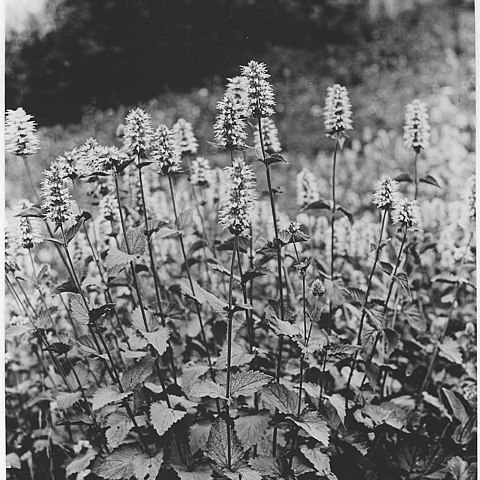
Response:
[206,417,244,470]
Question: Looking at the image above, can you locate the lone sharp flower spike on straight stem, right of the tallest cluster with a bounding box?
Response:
[323,84,353,137]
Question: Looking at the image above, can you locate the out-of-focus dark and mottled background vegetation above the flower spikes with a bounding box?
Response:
[6,0,475,212]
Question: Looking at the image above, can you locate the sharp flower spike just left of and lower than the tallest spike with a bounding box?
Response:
[213,94,247,150]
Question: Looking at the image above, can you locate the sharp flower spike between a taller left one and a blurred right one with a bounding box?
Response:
[150,125,181,175]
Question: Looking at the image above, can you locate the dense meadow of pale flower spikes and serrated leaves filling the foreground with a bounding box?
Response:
[5,61,477,480]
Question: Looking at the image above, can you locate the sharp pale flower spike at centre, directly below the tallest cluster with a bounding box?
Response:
[220,158,256,235]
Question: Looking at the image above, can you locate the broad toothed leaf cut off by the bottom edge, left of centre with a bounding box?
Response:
[92,445,142,480]
